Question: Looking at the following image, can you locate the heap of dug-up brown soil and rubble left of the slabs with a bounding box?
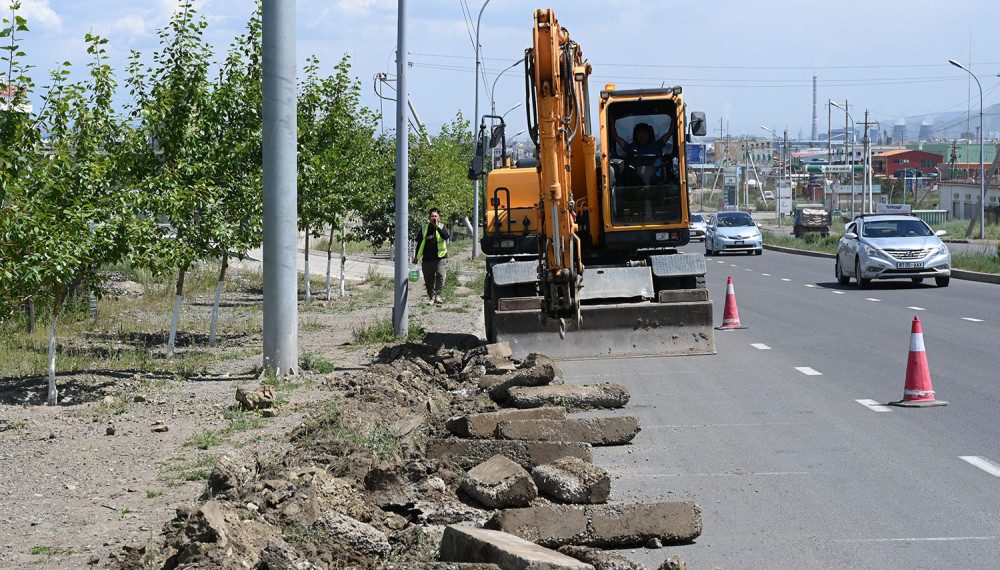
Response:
[119,343,508,569]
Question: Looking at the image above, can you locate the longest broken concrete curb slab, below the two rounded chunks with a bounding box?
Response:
[486,501,702,547]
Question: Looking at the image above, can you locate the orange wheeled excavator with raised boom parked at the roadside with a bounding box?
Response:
[469,9,715,358]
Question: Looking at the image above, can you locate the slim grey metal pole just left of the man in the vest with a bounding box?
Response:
[392,0,408,338]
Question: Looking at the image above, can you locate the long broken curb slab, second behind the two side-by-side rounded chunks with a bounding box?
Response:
[497,416,639,445]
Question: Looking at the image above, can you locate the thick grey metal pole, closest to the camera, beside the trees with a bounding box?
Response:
[262,0,298,375]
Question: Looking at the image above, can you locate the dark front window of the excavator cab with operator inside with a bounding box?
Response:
[608,100,681,226]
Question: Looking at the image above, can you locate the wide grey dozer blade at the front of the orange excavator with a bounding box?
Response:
[493,301,715,360]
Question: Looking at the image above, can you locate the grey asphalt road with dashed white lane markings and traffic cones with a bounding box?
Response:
[563,244,1000,570]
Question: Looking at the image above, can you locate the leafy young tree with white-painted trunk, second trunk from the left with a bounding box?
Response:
[128,1,227,357]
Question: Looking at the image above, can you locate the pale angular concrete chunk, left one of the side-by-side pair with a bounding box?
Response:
[461,455,538,509]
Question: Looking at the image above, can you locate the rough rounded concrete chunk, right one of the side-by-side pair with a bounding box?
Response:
[531,457,611,504]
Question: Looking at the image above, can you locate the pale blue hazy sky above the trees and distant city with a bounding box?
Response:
[0,0,1000,138]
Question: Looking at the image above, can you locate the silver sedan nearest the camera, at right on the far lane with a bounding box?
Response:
[834,214,951,288]
